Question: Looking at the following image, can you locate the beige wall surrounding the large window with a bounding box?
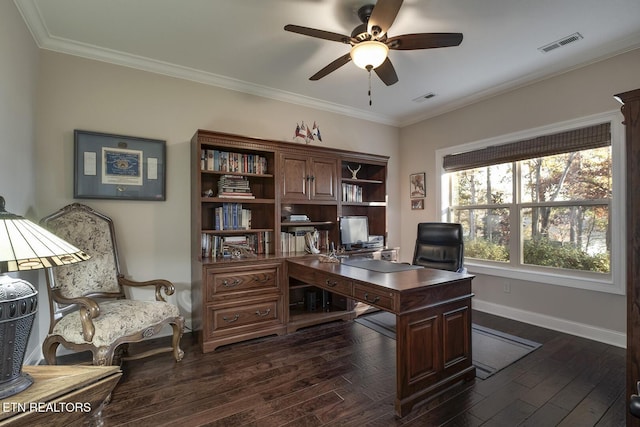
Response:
[400,50,640,344]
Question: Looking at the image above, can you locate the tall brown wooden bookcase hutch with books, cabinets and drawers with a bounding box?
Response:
[191,130,390,352]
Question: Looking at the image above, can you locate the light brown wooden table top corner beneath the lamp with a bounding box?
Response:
[0,365,122,426]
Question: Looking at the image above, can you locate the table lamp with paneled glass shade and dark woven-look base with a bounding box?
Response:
[0,196,90,399]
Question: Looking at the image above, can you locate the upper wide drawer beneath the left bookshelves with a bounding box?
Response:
[207,268,278,302]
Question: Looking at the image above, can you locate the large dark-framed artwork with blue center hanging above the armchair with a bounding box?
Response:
[73,129,166,201]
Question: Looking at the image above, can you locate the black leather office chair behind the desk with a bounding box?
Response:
[413,222,466,273]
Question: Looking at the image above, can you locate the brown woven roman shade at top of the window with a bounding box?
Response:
[442,122,611,172]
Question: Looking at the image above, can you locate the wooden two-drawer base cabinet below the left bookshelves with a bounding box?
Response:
[194,261,286,352]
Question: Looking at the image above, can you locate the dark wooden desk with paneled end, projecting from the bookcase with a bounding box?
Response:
[287,258,475,417]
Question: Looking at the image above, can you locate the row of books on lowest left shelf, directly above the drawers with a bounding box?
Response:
[201,231,273,258]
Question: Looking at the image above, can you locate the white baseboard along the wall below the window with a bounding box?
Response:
[472,298,627,348]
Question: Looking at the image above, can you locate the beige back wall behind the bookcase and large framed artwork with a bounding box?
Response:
[36,51,400,336]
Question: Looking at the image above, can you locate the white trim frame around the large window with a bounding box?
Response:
[436,111,626,295]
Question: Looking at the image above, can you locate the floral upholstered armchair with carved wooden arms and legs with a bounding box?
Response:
[41,203,184,365]
